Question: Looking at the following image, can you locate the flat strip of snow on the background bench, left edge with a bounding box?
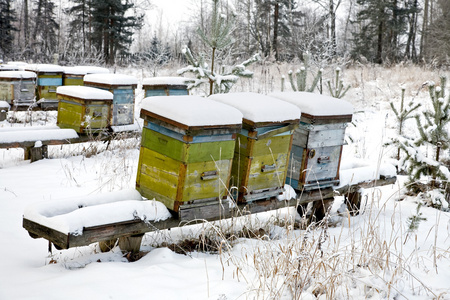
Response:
[0,129,78,143]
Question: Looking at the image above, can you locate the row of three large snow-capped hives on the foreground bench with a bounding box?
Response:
[136,92,353,219]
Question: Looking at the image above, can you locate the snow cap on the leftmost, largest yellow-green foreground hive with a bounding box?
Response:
[142,96,243,126]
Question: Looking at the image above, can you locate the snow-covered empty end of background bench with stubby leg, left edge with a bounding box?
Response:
[0,126,79,162]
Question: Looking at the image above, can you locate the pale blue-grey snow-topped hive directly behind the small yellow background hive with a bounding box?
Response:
[84,74,137,126]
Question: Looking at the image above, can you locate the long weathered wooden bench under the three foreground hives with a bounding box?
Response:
[23,171,396,252]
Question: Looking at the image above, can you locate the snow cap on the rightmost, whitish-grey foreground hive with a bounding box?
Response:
[269,92,353,116]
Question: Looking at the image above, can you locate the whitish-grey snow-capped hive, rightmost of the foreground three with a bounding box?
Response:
[270,92,353,190]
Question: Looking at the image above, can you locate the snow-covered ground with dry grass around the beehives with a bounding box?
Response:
[0,65,450,300]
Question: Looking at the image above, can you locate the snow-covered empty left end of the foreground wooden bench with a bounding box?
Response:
[23,190,174,252]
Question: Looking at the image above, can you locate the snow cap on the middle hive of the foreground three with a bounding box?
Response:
[209,93,301,122]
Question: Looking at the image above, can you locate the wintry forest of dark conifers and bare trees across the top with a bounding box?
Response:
[0,0,450,68]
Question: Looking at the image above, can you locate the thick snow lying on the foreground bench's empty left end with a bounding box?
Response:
[23,190,171,235]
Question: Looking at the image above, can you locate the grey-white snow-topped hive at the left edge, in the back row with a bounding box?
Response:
[0,71,36,106]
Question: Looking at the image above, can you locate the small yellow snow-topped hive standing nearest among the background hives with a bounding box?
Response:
[57,86,113,133]
